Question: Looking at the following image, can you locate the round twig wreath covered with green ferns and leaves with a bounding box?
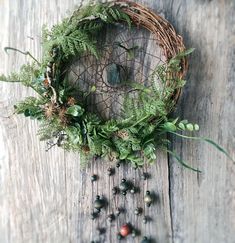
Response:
[1,1,231,171]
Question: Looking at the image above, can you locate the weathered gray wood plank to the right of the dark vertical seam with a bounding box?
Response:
[169,0,235,243]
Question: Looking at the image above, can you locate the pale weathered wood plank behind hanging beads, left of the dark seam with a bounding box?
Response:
[0,0,171,243]
